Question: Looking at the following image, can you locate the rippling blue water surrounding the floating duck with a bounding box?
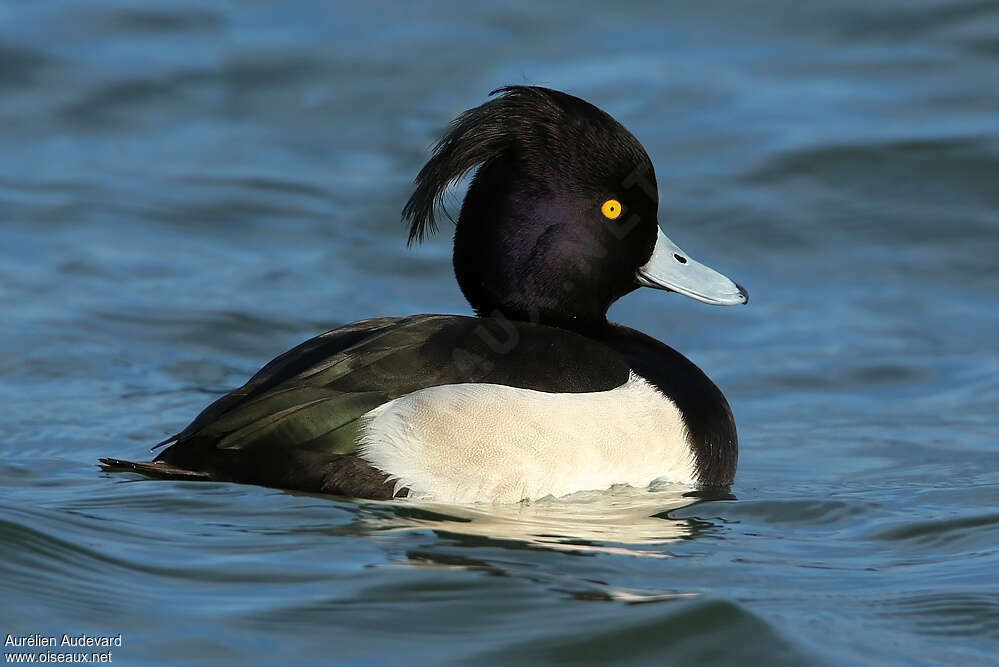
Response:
[0,0,999,665]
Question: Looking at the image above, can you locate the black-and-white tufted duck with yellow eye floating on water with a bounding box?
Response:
[100,86,749,503]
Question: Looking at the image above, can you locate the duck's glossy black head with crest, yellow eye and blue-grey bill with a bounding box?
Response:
[403,86,748,329]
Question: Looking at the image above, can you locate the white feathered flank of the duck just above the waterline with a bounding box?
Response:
[360,373,695,503]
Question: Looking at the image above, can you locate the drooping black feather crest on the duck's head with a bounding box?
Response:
[402,86,628,244]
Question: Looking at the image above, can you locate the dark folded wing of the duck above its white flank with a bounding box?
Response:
[119,315,629,495]
